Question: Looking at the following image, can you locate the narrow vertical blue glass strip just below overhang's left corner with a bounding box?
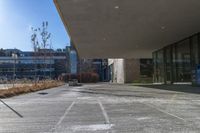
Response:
[70,51,77,74]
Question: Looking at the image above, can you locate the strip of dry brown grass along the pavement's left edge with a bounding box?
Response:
[0,81,64,98]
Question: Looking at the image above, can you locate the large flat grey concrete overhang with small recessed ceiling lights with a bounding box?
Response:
[54,0,200,58]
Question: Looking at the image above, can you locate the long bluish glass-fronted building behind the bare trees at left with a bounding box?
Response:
[0,49,68,79]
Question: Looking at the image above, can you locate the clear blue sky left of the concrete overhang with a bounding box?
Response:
[0,0,70,51]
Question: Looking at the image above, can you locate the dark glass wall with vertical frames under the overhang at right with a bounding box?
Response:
[153,33,200,84]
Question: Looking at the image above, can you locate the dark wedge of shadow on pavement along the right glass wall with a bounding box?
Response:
[134,85,200,94]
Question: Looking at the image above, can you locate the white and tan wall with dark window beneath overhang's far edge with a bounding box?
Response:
[108,59,153,83]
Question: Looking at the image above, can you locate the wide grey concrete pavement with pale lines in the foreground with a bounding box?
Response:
[0,84,200,133]
